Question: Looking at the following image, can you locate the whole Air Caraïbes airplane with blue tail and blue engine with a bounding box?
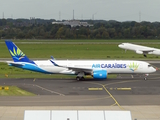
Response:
[5,40,156,81]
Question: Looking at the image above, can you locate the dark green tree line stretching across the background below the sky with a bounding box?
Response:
[0,19,160,39]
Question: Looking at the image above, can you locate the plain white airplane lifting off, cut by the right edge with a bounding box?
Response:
[118,43,160,57]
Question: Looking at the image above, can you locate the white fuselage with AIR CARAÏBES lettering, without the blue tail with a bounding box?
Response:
[30,60,156,74]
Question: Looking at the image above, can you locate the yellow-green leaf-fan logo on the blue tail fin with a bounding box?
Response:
[9,47,25,60]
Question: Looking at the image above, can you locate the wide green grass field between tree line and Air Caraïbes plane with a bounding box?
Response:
[0,40,160,60]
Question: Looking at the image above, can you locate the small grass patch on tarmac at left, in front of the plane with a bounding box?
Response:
[0,86,35,96]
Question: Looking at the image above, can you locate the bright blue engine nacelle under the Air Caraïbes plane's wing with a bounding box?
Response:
[93,70,107,79]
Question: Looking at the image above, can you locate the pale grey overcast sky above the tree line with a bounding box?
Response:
[0,0,160,22]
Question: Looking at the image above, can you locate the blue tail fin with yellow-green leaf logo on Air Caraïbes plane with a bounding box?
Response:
[5,41,35,64]
